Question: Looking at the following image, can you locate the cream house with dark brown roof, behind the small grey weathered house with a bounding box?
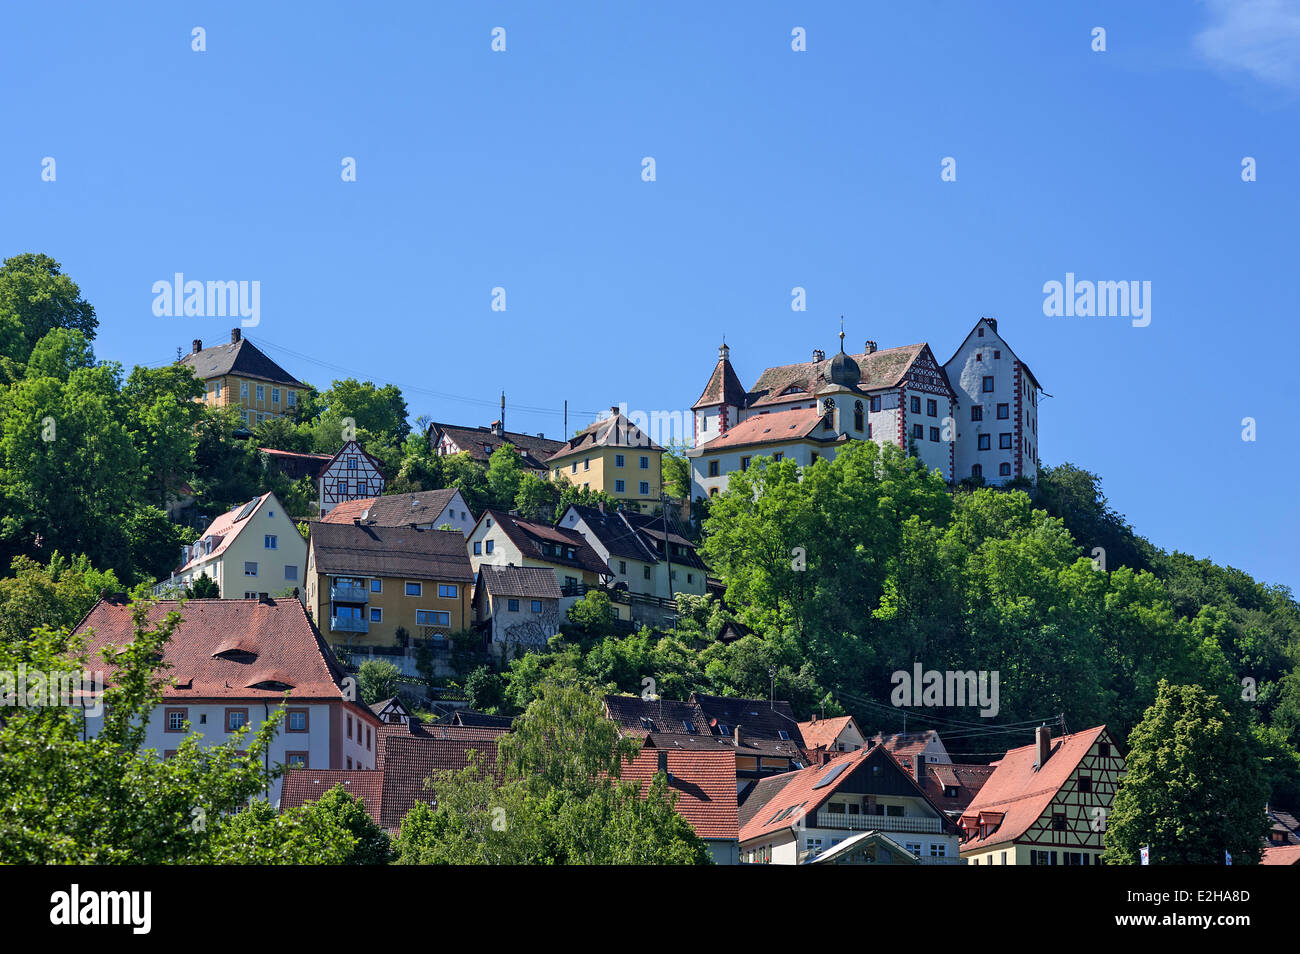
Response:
[465,509,610,620]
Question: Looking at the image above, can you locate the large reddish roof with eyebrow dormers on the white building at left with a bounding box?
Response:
[75,598,378,723]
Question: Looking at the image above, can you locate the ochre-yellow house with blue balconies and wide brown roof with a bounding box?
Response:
[306,519,475,649]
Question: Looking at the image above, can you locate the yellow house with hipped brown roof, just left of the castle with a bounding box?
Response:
[546,407,663,509]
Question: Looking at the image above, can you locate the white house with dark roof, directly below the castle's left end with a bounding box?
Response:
[556,504,707,626]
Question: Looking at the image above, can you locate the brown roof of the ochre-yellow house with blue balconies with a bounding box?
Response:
[311,520,475,584]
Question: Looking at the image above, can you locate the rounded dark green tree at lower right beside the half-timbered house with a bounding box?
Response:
[1104,681,1269,864]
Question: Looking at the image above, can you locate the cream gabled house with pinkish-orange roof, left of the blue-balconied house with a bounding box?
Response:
[155,494,307,599]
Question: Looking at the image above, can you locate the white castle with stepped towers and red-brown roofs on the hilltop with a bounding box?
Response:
[686,318,1041,498]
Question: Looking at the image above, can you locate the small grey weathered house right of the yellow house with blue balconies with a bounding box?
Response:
[473,563,562,660]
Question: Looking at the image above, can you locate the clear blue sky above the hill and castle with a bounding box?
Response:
[0,0,1300,587]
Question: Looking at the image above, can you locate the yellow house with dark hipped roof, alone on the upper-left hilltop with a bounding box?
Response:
[181,328,306,428]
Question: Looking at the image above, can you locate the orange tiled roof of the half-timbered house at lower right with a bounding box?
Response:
[961,725,1106,854]
